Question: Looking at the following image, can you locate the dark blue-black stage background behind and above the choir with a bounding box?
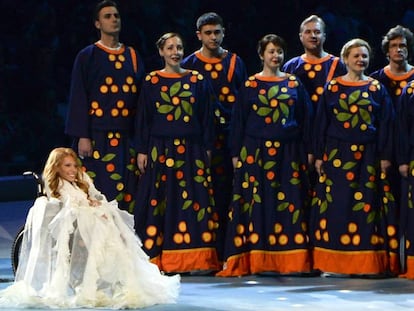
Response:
[0,0,414,175]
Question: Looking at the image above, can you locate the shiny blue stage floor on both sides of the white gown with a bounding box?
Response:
[0,203,414,311]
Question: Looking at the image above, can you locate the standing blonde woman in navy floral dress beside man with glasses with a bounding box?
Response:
[310,39,398,277]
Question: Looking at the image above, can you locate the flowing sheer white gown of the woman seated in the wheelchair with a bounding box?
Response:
[0,174,180,309]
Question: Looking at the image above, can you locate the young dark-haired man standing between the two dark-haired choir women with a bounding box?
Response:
[182,12,247,256]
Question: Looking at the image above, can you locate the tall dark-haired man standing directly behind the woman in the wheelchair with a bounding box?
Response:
[65,0,144,212]
